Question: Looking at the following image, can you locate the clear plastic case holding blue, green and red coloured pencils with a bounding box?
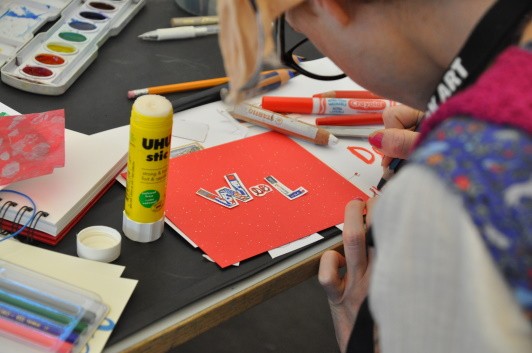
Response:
[0,260,109,353]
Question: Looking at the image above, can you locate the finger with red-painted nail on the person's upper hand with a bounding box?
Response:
[368,128,418,159]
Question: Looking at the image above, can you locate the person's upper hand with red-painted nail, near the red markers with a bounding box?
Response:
[368,105,423,168]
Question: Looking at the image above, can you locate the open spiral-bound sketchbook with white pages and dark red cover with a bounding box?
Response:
[0,126,129,245]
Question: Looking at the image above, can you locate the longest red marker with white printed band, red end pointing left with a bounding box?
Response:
[262,96,397,115]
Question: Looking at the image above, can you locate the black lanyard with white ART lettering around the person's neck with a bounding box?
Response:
[426,0,532,116]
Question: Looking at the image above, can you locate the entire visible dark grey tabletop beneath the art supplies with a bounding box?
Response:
[0,0,339,344]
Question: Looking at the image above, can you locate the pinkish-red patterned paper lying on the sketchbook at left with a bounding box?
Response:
[0,109,65,185]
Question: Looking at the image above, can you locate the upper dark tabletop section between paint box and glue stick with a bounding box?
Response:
[0,0,225,134]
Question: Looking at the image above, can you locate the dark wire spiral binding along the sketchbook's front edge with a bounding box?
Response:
[0,197,49,241]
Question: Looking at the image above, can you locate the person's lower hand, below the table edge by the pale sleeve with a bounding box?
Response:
[318,198,375,352]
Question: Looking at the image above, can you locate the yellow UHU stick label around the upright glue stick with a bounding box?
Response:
[124,96,172,223]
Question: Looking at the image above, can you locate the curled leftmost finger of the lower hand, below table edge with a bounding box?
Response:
[318,250,346,303]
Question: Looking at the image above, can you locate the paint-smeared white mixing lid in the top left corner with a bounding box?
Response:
[0,0,76,67]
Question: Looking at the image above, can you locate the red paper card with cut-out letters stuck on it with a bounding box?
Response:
[165,132,367,267]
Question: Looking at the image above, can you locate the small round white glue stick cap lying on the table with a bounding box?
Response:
[76,226,122,262]
